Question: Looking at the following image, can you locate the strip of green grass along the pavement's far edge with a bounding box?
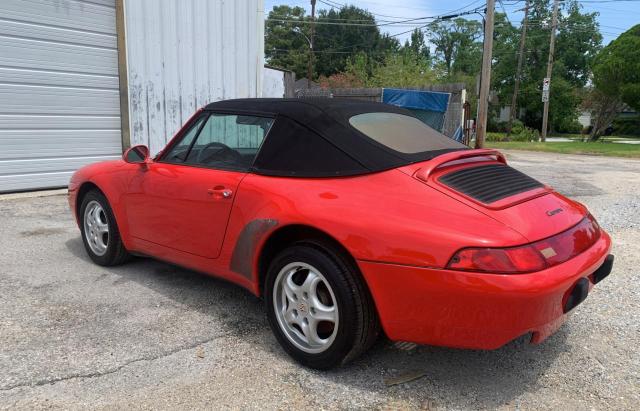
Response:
[486,141,640,158]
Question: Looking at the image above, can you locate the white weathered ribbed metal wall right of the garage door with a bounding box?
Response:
[124,0,264,153]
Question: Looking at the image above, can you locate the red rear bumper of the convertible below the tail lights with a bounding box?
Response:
[358,232,612,349]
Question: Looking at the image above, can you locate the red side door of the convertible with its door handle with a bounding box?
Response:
[124,163,245,258]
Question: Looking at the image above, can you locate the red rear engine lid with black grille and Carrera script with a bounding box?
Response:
[403,150,587,241]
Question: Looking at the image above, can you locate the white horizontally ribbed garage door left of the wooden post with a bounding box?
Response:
[0,0,122,192]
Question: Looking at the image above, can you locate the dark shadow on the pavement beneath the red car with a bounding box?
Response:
[66,238,569,408]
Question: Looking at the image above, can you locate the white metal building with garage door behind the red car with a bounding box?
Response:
[0,0,264,192]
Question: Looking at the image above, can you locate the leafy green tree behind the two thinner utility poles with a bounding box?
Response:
[492,0,602,131]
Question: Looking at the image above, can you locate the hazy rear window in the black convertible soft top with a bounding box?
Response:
[349,113,467,154]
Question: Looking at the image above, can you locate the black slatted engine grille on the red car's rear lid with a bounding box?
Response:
[438,164,544,204]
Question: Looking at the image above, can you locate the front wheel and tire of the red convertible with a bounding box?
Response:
[79,190,131,266]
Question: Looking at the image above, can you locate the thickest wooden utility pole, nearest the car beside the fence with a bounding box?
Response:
[476,0,496,148]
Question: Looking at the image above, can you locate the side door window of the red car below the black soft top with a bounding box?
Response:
[184,114,273,170]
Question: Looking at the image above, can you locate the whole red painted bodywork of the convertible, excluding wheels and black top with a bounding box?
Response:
[69,118,611,349]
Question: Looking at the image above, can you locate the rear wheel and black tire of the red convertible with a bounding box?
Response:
[264,242,380,370]
